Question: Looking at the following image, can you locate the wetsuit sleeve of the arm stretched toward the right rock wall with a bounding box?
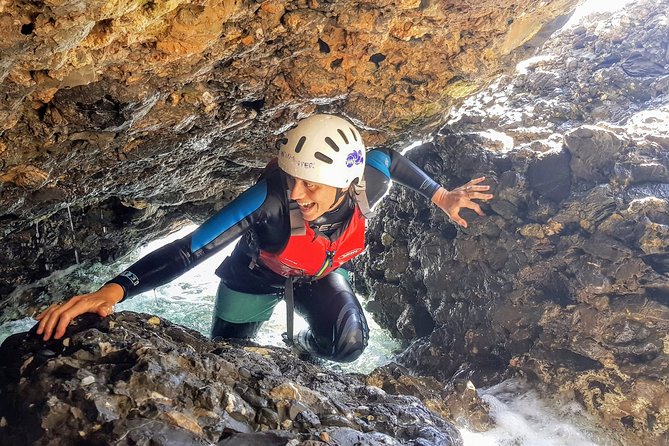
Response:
[365,149,439,205]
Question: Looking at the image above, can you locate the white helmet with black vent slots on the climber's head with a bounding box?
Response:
[279,115,365,188]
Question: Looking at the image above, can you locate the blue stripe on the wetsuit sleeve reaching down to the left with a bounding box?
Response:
[190,180,267,252]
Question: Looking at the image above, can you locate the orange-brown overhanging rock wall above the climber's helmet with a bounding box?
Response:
[0,0,578,306]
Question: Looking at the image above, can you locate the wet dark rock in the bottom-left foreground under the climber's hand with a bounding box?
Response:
[0,312,464,446]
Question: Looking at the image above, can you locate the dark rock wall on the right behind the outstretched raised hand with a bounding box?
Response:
[356,1,669,445]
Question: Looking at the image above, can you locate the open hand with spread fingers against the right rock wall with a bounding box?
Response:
[432,177,493,228]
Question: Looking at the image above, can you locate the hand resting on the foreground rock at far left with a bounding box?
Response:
[35,283,123,341]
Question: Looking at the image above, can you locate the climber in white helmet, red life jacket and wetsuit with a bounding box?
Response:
[37,115,492,362]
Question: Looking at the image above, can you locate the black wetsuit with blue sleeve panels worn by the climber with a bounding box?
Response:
[110,149,439,361]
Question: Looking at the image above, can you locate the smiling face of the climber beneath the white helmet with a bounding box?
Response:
[286,175,345,221]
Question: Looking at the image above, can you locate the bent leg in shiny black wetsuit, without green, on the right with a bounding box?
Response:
[295,272,369,362]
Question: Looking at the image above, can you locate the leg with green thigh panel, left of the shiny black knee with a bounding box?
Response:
[211,282,279,339]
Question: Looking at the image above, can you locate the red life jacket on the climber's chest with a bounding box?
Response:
[259,206,366,279]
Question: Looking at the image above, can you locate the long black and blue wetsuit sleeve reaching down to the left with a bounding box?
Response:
[107,180,268,299]
